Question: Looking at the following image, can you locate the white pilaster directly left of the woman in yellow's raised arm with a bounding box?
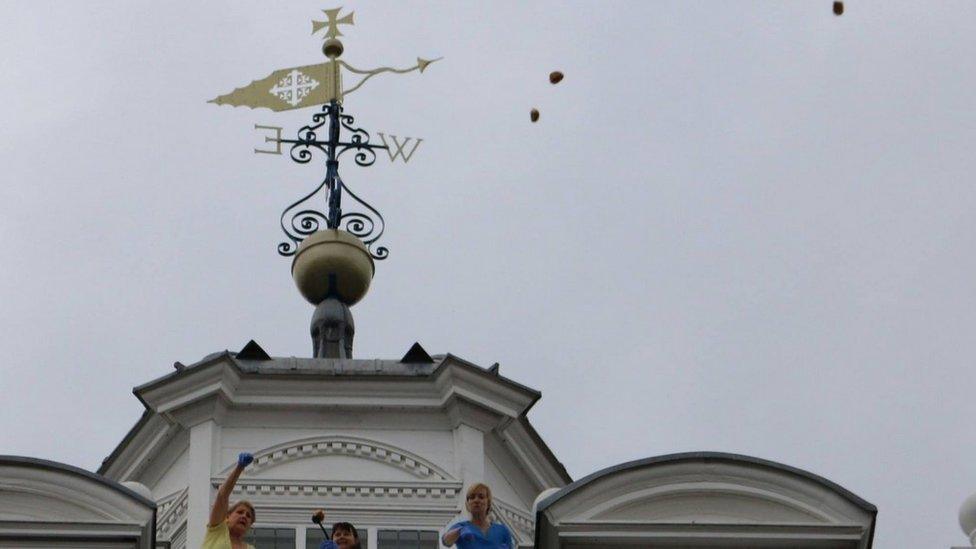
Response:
[186,419,219,549]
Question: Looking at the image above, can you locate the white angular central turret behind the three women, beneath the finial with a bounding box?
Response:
[99,342,571,549]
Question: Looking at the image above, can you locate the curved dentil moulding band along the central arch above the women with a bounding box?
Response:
[222,436,454,482]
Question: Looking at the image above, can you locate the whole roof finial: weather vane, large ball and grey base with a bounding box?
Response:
[211,8,436,358]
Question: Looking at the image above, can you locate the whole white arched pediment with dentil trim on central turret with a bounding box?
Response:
[222,436,455,482]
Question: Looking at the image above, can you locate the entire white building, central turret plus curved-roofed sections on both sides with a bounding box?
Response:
[0,342,884,549]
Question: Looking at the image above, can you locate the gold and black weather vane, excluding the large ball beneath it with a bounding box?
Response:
[210,8,440,259]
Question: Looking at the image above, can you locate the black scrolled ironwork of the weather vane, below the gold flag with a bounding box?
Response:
[278,100,390,259]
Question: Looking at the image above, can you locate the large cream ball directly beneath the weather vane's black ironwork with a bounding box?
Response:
[291,229,376,305]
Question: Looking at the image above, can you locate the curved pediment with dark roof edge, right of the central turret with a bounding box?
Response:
[537,452,877,547]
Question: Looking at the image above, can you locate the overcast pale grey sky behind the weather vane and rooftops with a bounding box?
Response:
[0,0,976,548]
